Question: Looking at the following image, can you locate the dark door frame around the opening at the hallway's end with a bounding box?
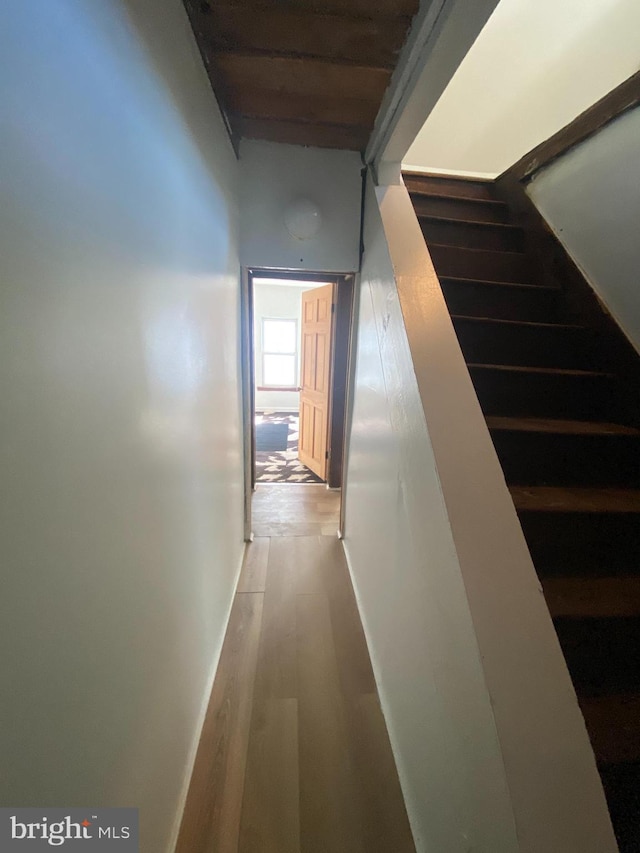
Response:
[240,267,356,542]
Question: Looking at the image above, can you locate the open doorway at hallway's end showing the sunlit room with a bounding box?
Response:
[245,270,354,531]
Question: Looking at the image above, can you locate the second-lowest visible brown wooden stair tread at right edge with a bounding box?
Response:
[542,576,640,619]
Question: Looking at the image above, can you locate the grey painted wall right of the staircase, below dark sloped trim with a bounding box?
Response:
[527,108,640,352]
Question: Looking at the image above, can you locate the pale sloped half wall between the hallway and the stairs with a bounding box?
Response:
[343,176,617,853]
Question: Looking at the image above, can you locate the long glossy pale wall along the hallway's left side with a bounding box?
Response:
[0,0,242,853]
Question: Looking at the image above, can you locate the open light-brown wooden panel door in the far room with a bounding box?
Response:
[298,284,334,480]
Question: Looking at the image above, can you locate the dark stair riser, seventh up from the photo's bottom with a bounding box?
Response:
[440,278,563,323]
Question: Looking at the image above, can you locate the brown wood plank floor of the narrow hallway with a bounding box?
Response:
[176,486,415,853]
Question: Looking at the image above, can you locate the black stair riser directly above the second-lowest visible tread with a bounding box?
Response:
[518,510,640,577]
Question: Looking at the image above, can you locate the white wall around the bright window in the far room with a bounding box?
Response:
[253,281,318,412]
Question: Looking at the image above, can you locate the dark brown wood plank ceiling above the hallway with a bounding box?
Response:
[184,0,419,151]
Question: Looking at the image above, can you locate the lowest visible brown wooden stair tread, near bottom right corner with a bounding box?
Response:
[580,694,640,764]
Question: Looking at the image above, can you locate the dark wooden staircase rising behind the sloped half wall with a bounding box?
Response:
[404,175,640,853]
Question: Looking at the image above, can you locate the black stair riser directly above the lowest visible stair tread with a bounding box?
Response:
[554,617,640,696]
